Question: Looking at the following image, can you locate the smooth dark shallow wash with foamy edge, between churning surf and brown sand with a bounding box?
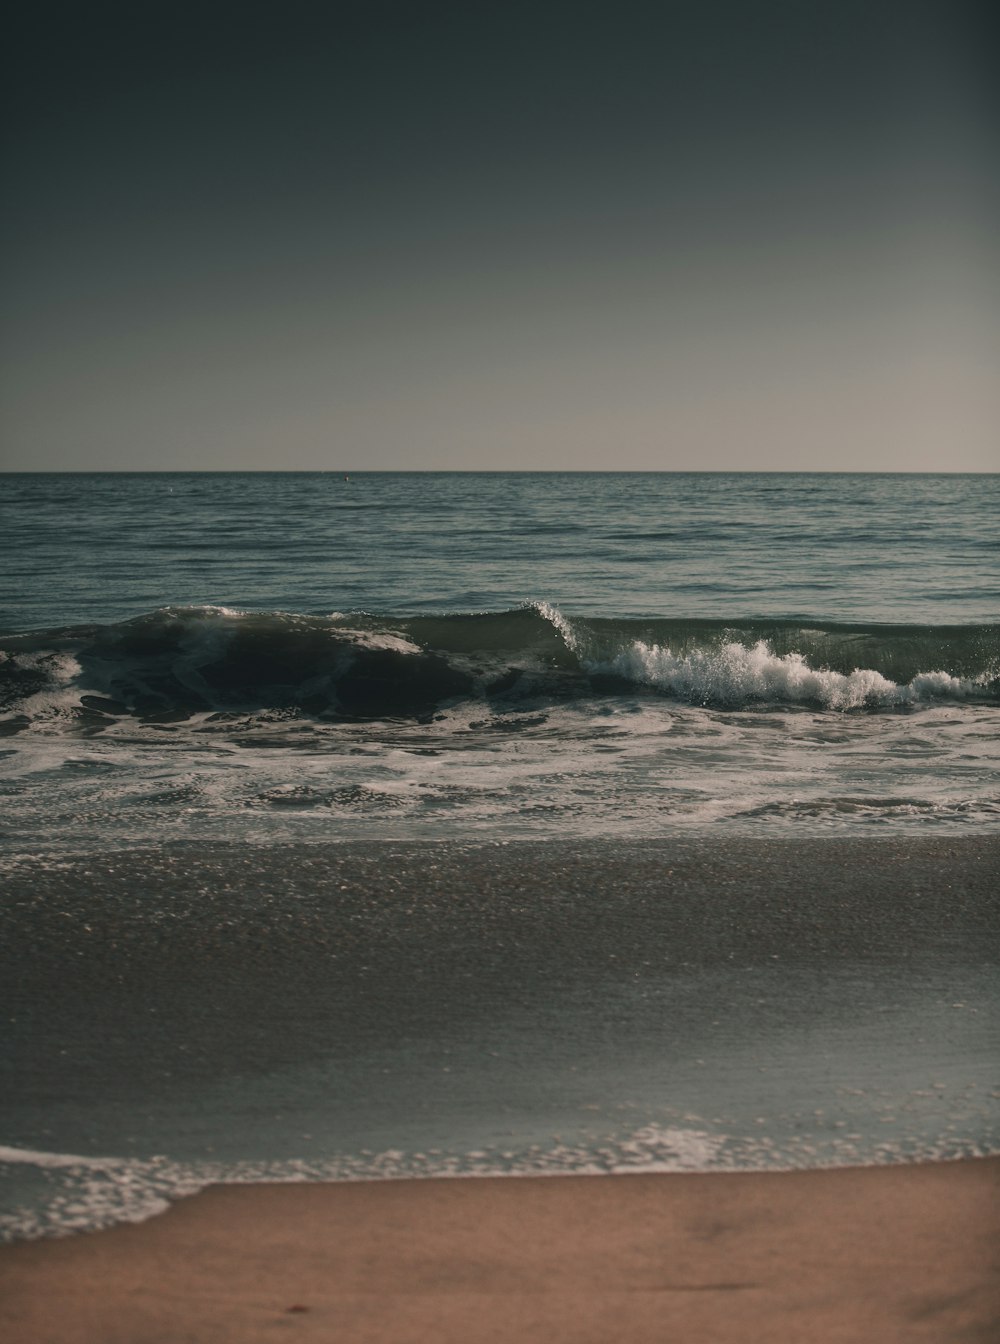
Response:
[0,836,1000,1241]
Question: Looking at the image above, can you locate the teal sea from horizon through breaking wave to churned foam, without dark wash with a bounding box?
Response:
[0,472,1000,852]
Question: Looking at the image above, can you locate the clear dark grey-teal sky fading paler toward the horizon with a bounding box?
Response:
[0,0,1000,470]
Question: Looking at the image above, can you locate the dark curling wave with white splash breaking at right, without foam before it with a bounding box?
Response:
[0,603,1000,731]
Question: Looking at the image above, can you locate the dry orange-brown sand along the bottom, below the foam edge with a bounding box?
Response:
[0,1159,1000,1344]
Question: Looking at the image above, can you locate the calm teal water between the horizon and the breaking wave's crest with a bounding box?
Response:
[0,472,1000,630]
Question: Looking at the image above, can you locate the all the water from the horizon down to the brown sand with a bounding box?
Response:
[0,470,1000,1239]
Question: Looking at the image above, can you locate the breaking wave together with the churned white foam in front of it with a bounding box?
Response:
[0,603,1000,853]
